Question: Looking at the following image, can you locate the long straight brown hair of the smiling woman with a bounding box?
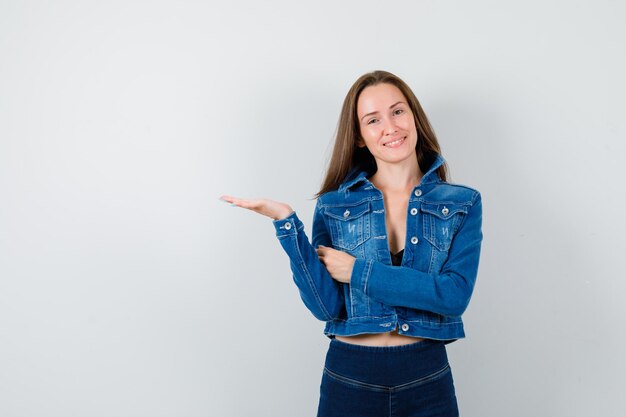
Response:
[315,71,448,198]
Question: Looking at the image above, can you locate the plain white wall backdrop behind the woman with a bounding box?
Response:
[0,0,626,417]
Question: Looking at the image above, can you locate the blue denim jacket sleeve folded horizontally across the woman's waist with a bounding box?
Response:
[350,192,483,316]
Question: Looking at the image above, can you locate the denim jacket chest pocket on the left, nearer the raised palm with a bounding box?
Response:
[324,200,371,251]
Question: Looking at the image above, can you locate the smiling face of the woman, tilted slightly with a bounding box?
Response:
[357,83,417,163]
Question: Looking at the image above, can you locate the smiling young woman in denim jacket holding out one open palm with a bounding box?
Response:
[221,71,482,417]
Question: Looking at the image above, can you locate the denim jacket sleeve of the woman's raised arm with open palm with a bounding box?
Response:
[273,198,344,321]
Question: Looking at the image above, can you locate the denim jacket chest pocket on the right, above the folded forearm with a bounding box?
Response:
[420,202,468,251]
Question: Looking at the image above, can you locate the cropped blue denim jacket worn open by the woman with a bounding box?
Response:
[273,155,483,343]
